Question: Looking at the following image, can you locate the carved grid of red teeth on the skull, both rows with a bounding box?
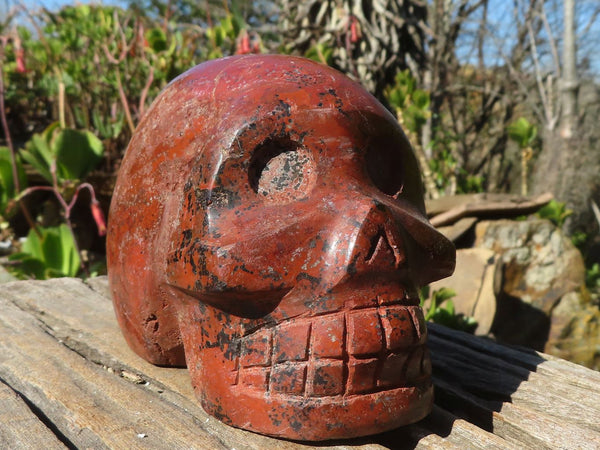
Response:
[227,304,431,397]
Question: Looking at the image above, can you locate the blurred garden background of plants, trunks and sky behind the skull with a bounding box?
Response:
[0,0,600,294]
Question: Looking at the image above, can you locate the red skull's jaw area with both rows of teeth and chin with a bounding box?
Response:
[176,302,433,440]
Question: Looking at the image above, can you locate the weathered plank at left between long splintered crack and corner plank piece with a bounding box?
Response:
[0,288,248,449]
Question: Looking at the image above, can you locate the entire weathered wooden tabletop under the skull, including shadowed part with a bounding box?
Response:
[0,278,600,450]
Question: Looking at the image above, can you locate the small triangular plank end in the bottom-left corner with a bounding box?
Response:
[0,381,66,450]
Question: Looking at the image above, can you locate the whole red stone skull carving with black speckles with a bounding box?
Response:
[108,55,454,440]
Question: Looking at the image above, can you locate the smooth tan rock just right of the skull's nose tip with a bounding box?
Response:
[431,248,497,335]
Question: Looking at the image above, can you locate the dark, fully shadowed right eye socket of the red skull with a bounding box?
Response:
[365,144,404,197]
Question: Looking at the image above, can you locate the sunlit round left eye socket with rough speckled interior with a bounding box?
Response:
[248,137,316,203]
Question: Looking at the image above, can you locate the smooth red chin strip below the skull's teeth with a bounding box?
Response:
[195,379,433,441]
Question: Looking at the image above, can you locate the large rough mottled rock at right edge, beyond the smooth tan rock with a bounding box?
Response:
[472,219,600,367]
